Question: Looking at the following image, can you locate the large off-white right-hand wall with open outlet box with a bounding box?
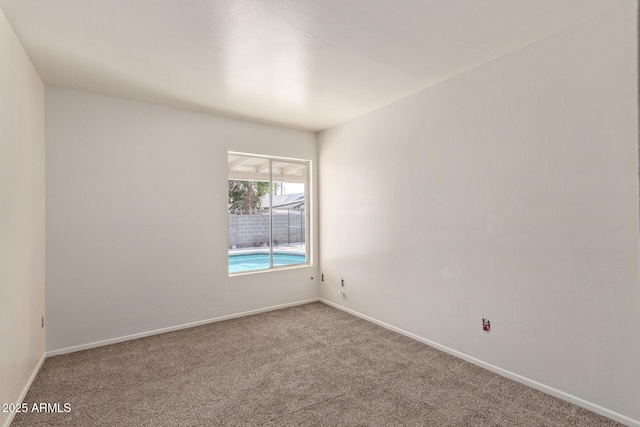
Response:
[319,2,640,422]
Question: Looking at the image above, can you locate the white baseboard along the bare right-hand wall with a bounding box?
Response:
[319,298,640,427]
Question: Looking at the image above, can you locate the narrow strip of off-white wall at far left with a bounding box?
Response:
[0,6,45,425]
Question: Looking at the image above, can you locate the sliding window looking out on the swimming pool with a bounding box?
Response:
[228,152,309,275]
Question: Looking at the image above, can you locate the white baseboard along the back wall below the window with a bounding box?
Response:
[46,298,320,357]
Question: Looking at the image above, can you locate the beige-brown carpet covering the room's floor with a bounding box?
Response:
[12,303,619,427]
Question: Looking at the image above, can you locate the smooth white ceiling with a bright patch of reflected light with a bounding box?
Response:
[0,0,632,130]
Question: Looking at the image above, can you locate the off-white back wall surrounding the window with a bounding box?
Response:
[45,87,317,352]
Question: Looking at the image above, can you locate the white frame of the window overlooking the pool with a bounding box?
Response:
[227,150,313,277]
